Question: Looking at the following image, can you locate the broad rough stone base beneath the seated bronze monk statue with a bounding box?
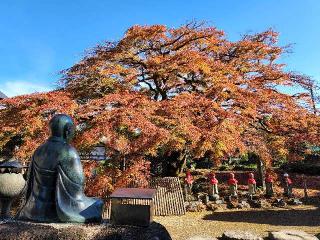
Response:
[0,221,171,240]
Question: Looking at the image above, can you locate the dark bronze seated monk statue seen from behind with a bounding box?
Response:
[17,114,103,223]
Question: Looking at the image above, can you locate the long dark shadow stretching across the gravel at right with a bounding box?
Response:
[203,208,320,226]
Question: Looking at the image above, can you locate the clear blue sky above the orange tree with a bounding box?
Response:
[0,0,320,96]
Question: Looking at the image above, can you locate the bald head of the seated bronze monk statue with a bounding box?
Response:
[49,114,75,142]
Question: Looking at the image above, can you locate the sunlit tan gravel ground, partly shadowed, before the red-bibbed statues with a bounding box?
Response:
[154,206,320,240]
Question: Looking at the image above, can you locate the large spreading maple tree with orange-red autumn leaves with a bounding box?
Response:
[0,22,320,196]
